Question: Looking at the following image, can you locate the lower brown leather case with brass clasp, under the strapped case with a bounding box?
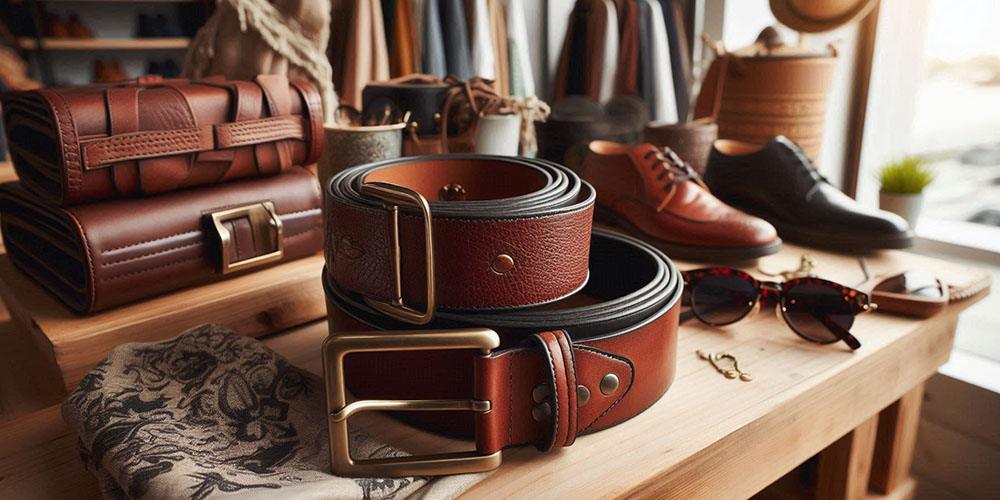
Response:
[0,167,322,313]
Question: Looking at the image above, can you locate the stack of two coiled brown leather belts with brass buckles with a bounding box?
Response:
[323,156,682,476]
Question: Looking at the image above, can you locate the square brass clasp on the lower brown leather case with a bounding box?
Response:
[210,201,285,274]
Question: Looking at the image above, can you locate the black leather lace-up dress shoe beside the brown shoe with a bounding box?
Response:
[704,135,913,251]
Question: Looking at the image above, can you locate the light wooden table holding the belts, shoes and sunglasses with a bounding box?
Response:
[0,246,987,499]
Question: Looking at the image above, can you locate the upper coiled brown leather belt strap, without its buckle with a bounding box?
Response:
[324,155,595,309]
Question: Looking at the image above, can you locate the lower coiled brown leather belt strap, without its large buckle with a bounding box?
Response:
[324,230,682,454]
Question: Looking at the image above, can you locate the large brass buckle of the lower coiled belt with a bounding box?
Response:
[323,328,501,477]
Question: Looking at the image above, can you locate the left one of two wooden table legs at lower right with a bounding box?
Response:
[816,415,879,500]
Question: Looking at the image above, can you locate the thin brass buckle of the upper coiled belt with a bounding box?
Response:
[361,182,435,325]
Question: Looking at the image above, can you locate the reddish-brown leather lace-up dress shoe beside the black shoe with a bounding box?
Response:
[580,141,781,260]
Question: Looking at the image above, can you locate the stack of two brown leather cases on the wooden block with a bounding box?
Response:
[0,75,323,313]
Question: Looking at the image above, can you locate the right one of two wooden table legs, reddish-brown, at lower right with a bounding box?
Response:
[870,384,924,494]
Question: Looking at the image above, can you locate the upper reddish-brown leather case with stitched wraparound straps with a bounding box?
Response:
[3,75,323,206]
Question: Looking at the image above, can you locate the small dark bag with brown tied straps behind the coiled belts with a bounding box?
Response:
[361,74,503,156]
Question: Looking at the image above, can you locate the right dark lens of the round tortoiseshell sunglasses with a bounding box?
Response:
[783,284,854,344]
